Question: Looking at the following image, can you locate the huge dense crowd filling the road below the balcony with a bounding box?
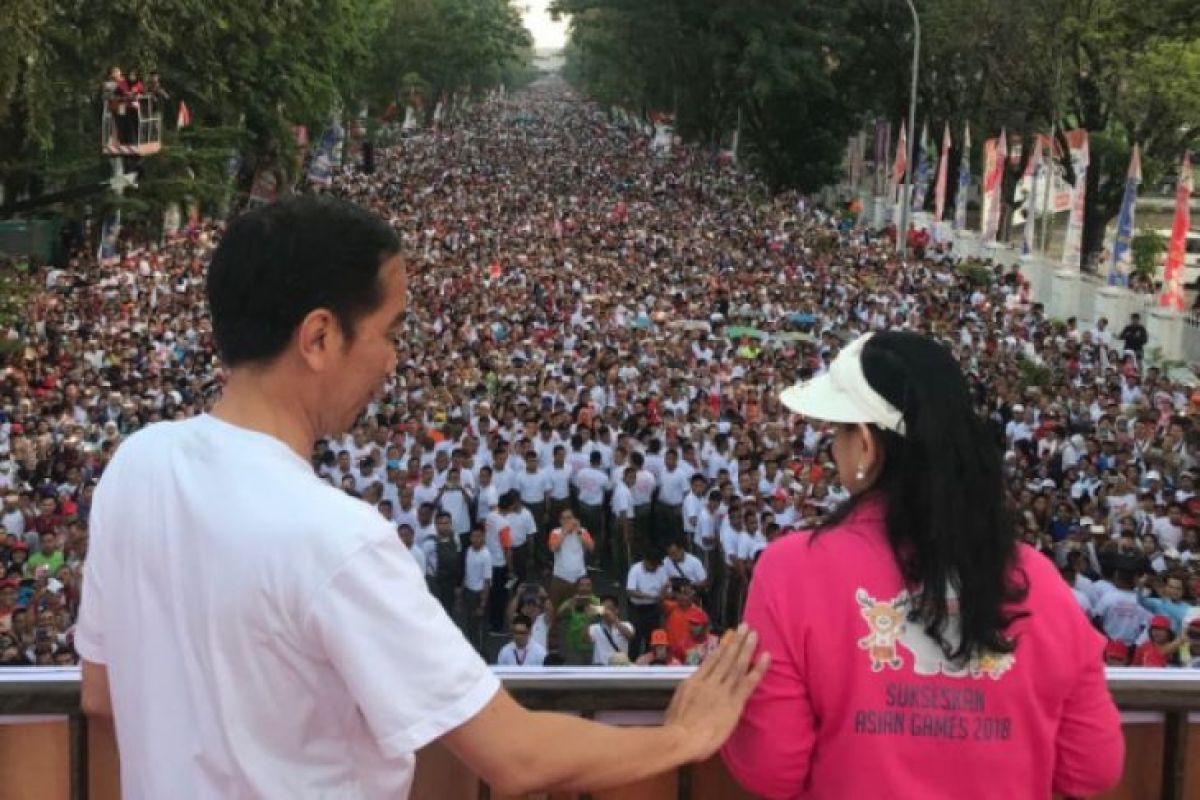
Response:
[0,80,1200,667]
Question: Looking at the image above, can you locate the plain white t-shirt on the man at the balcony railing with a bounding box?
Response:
[76,415,499,799]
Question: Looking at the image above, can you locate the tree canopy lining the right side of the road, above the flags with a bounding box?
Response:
[553,0,1200,262]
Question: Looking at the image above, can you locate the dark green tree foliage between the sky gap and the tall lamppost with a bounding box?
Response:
[553,0,860,190]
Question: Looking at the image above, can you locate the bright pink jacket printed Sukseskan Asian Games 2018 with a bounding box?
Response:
[721,503,1124,800]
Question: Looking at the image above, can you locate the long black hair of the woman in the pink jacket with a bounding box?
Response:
[817,331,1028,663]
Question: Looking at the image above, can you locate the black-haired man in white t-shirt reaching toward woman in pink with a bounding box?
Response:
[74,197,767,800]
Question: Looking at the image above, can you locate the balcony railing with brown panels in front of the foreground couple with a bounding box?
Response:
[0,668,1200,800]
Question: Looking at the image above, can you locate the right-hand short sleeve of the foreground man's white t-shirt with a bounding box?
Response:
[305,540,500,757]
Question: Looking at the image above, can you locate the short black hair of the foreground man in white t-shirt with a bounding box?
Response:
[208,197,400,366]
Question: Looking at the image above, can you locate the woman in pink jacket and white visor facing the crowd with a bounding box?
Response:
[722,332,1124,800]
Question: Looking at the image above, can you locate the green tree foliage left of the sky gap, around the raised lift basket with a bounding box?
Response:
[0,0,529,221]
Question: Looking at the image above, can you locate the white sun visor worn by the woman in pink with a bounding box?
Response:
[779,333,905,435]
